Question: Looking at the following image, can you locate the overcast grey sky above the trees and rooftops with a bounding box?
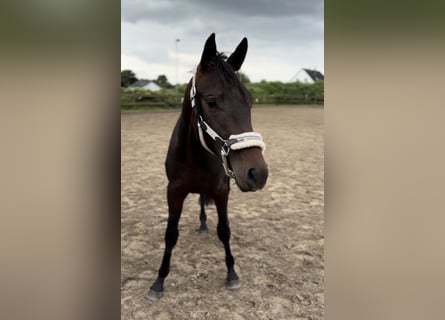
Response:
[121,0,324,83]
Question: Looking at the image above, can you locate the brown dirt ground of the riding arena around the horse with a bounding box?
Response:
[121,107,324,320]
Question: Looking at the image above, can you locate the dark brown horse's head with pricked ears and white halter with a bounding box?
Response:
[190,34,268,191]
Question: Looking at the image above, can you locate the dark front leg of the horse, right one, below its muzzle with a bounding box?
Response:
[215,191,241,289]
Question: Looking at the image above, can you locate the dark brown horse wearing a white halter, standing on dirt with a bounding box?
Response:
[147,33,268,301]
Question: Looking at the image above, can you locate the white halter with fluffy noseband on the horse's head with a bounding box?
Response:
[190,76,266,179]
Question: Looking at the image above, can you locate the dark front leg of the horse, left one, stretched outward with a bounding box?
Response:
[147,184,187,301]
